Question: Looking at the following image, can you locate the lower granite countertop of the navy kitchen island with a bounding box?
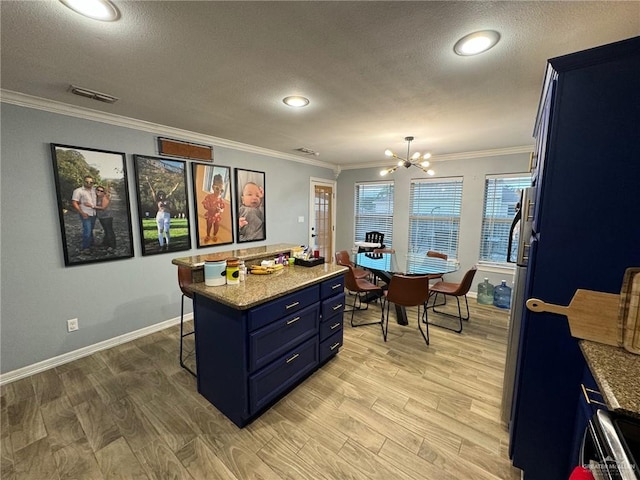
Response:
[187,263,347,310]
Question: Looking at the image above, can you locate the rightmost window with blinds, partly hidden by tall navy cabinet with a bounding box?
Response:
[480,174,531,263]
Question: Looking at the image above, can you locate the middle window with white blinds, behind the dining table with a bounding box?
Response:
[407,177,462,265]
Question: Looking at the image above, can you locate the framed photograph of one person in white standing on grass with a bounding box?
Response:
[134,155,191,255]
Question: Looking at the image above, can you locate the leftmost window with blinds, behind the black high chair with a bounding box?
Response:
[355,181,393,248]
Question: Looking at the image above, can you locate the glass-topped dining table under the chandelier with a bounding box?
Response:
[355,252,460,325]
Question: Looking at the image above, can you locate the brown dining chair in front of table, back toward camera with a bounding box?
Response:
[380,274,429,345]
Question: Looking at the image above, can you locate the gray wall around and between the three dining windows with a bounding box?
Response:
[336,153,529,291]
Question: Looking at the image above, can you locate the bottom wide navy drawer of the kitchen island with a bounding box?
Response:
[249,336,318,415]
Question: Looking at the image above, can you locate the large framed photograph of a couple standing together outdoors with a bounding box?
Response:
[51,143,133,266]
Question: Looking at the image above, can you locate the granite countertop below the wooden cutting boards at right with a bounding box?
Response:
[579,340,640,418]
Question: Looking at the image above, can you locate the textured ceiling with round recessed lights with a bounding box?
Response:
[0,0,640,168]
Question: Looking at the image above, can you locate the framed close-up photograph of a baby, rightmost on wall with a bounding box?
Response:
[235,168,267,243]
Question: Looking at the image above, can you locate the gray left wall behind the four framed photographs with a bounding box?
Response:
[0,103,334,373]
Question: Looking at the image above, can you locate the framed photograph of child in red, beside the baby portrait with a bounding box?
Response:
[191,163,233,247]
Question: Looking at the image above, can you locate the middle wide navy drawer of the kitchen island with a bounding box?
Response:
[249,303,319,372]
